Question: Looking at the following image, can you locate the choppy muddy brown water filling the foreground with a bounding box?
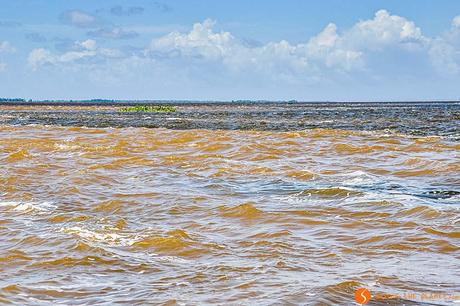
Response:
[0,125,460,305]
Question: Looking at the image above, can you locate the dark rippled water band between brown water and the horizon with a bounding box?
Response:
[0,102,460,139]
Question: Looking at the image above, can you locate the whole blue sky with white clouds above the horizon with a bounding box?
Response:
[0,0,460,101]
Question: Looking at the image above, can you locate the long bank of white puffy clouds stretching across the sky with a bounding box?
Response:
[29,9,460,84]
